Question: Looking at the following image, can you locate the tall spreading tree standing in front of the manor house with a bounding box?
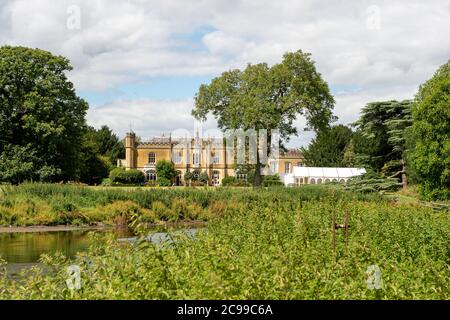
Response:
[192,50,334,185]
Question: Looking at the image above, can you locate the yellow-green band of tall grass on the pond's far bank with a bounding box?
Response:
[0,184,384,226]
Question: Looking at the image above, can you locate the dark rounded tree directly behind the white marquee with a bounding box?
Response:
[301,124,353,167]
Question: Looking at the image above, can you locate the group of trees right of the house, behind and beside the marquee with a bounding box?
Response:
[302,61,450,199]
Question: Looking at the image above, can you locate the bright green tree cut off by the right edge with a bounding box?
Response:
[410,60,450,199]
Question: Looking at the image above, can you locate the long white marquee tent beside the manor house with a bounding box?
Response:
[282,167,366,186]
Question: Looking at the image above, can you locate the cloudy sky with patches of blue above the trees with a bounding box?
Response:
[0,0,450,146]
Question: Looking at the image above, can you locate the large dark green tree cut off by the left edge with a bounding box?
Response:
[0,46,88,183]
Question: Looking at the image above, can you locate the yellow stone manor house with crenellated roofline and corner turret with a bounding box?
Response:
[118,133,304,185]
